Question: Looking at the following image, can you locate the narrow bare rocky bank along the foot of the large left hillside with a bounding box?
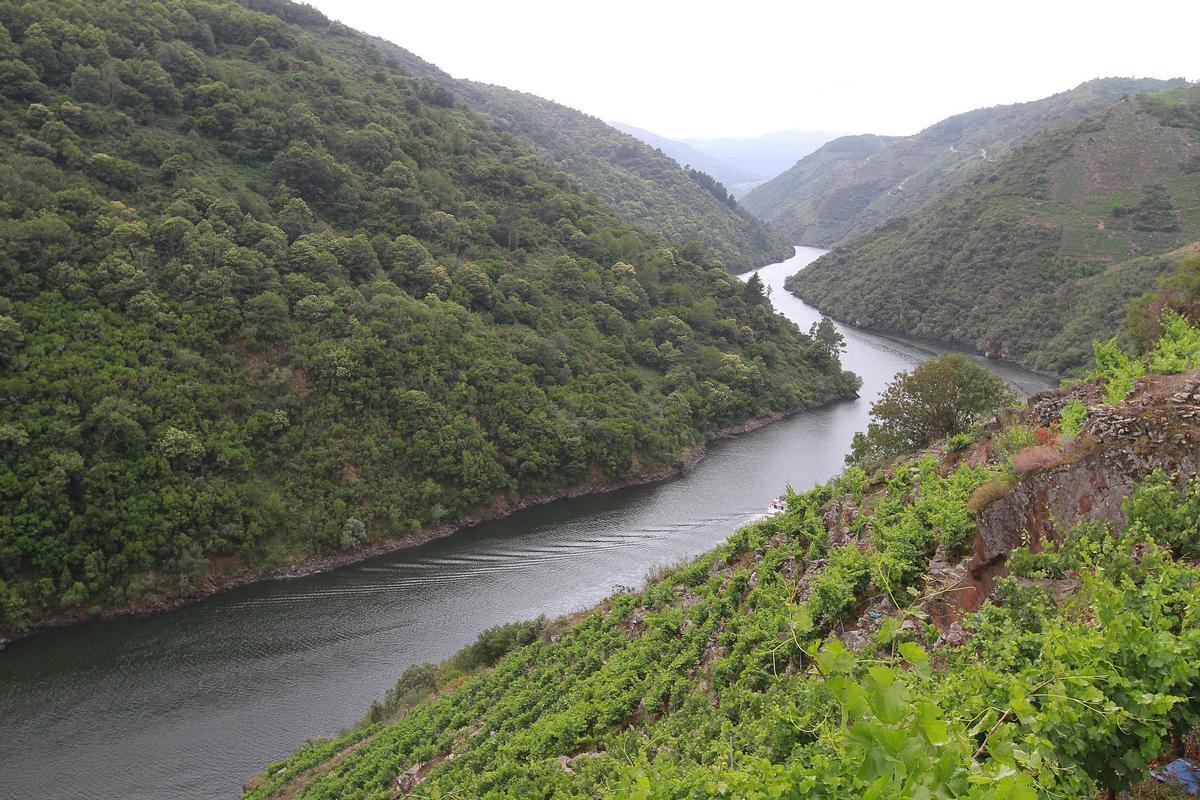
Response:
[0,392,858,650]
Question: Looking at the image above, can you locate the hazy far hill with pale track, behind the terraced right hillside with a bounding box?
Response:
[743,78,1183,247]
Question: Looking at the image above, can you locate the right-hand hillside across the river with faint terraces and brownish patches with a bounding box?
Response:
[788,86,1200,372]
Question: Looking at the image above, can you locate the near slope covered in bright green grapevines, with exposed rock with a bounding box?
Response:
[246,324,1200,800]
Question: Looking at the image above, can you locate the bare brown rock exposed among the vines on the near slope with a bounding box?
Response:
[825,372,1200,649]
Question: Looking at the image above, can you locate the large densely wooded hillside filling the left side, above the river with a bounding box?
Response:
[0,0,856,630]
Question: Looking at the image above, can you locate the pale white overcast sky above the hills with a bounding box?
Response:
[308,0,1200,138]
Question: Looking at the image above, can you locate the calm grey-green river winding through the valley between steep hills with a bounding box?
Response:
[0,247,1049,800]
